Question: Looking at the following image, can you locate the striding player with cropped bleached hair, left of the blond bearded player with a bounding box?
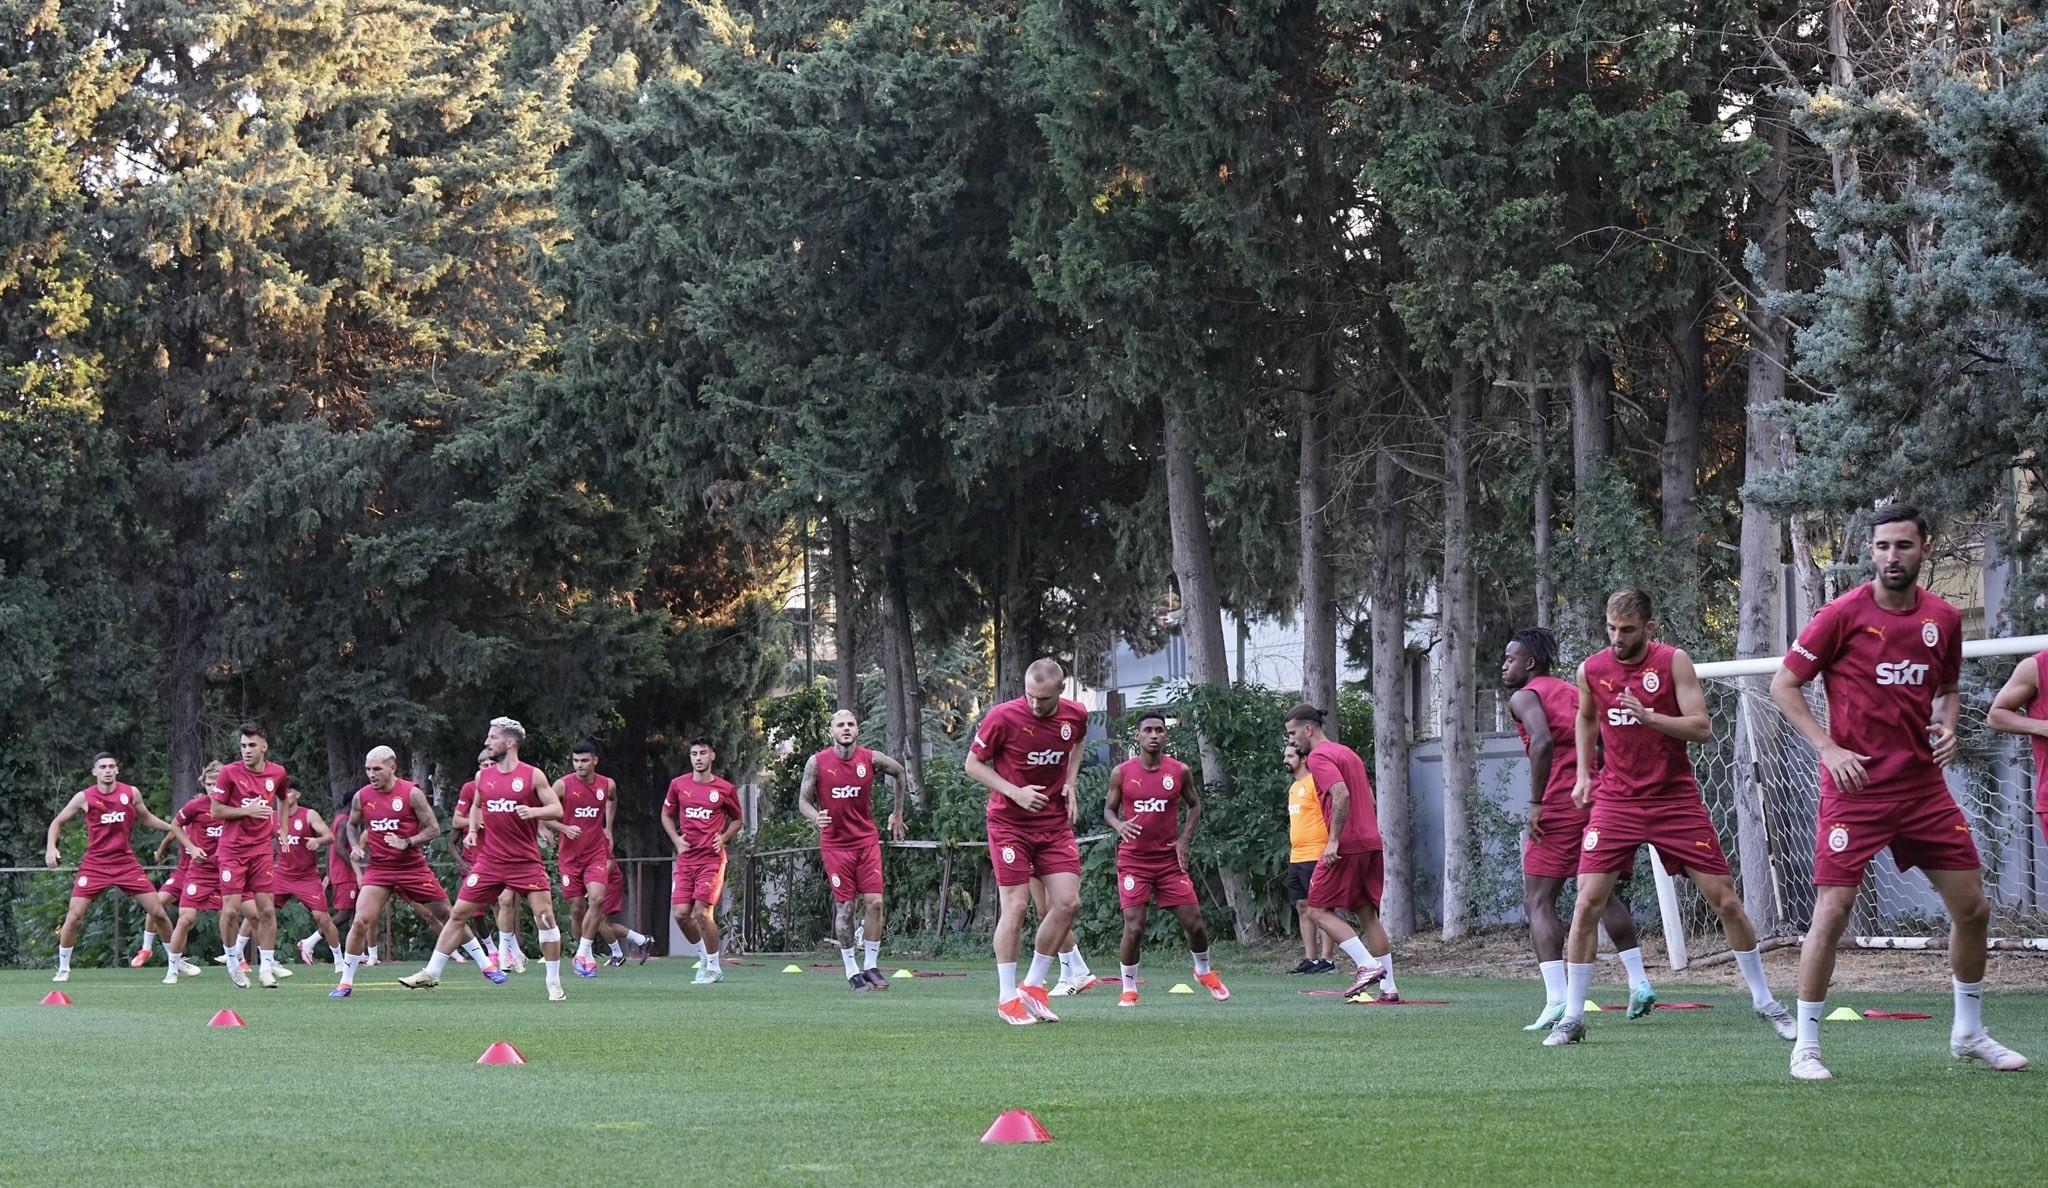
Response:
[328,746,506,998]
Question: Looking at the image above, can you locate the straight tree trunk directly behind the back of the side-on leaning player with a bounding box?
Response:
[1372,442,1415,940]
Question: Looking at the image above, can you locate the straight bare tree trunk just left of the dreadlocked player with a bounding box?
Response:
[1440,369,1479,940]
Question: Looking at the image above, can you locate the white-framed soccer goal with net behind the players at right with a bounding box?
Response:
[1651,635,2048,969]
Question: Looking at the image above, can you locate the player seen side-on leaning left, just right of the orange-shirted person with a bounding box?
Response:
[1286,703,1401,1004]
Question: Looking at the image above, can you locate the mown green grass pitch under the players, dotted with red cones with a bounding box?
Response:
[0,959,2048,1188]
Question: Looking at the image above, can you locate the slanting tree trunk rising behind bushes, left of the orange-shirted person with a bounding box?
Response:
[1163,395,1262,944]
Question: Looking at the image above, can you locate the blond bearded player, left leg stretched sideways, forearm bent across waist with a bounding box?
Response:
[397,717,567,1002]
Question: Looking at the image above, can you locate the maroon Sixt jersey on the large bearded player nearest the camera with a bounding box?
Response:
[1786,582,1962,797]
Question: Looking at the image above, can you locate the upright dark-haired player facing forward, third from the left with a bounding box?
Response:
[209,721,291,989]
